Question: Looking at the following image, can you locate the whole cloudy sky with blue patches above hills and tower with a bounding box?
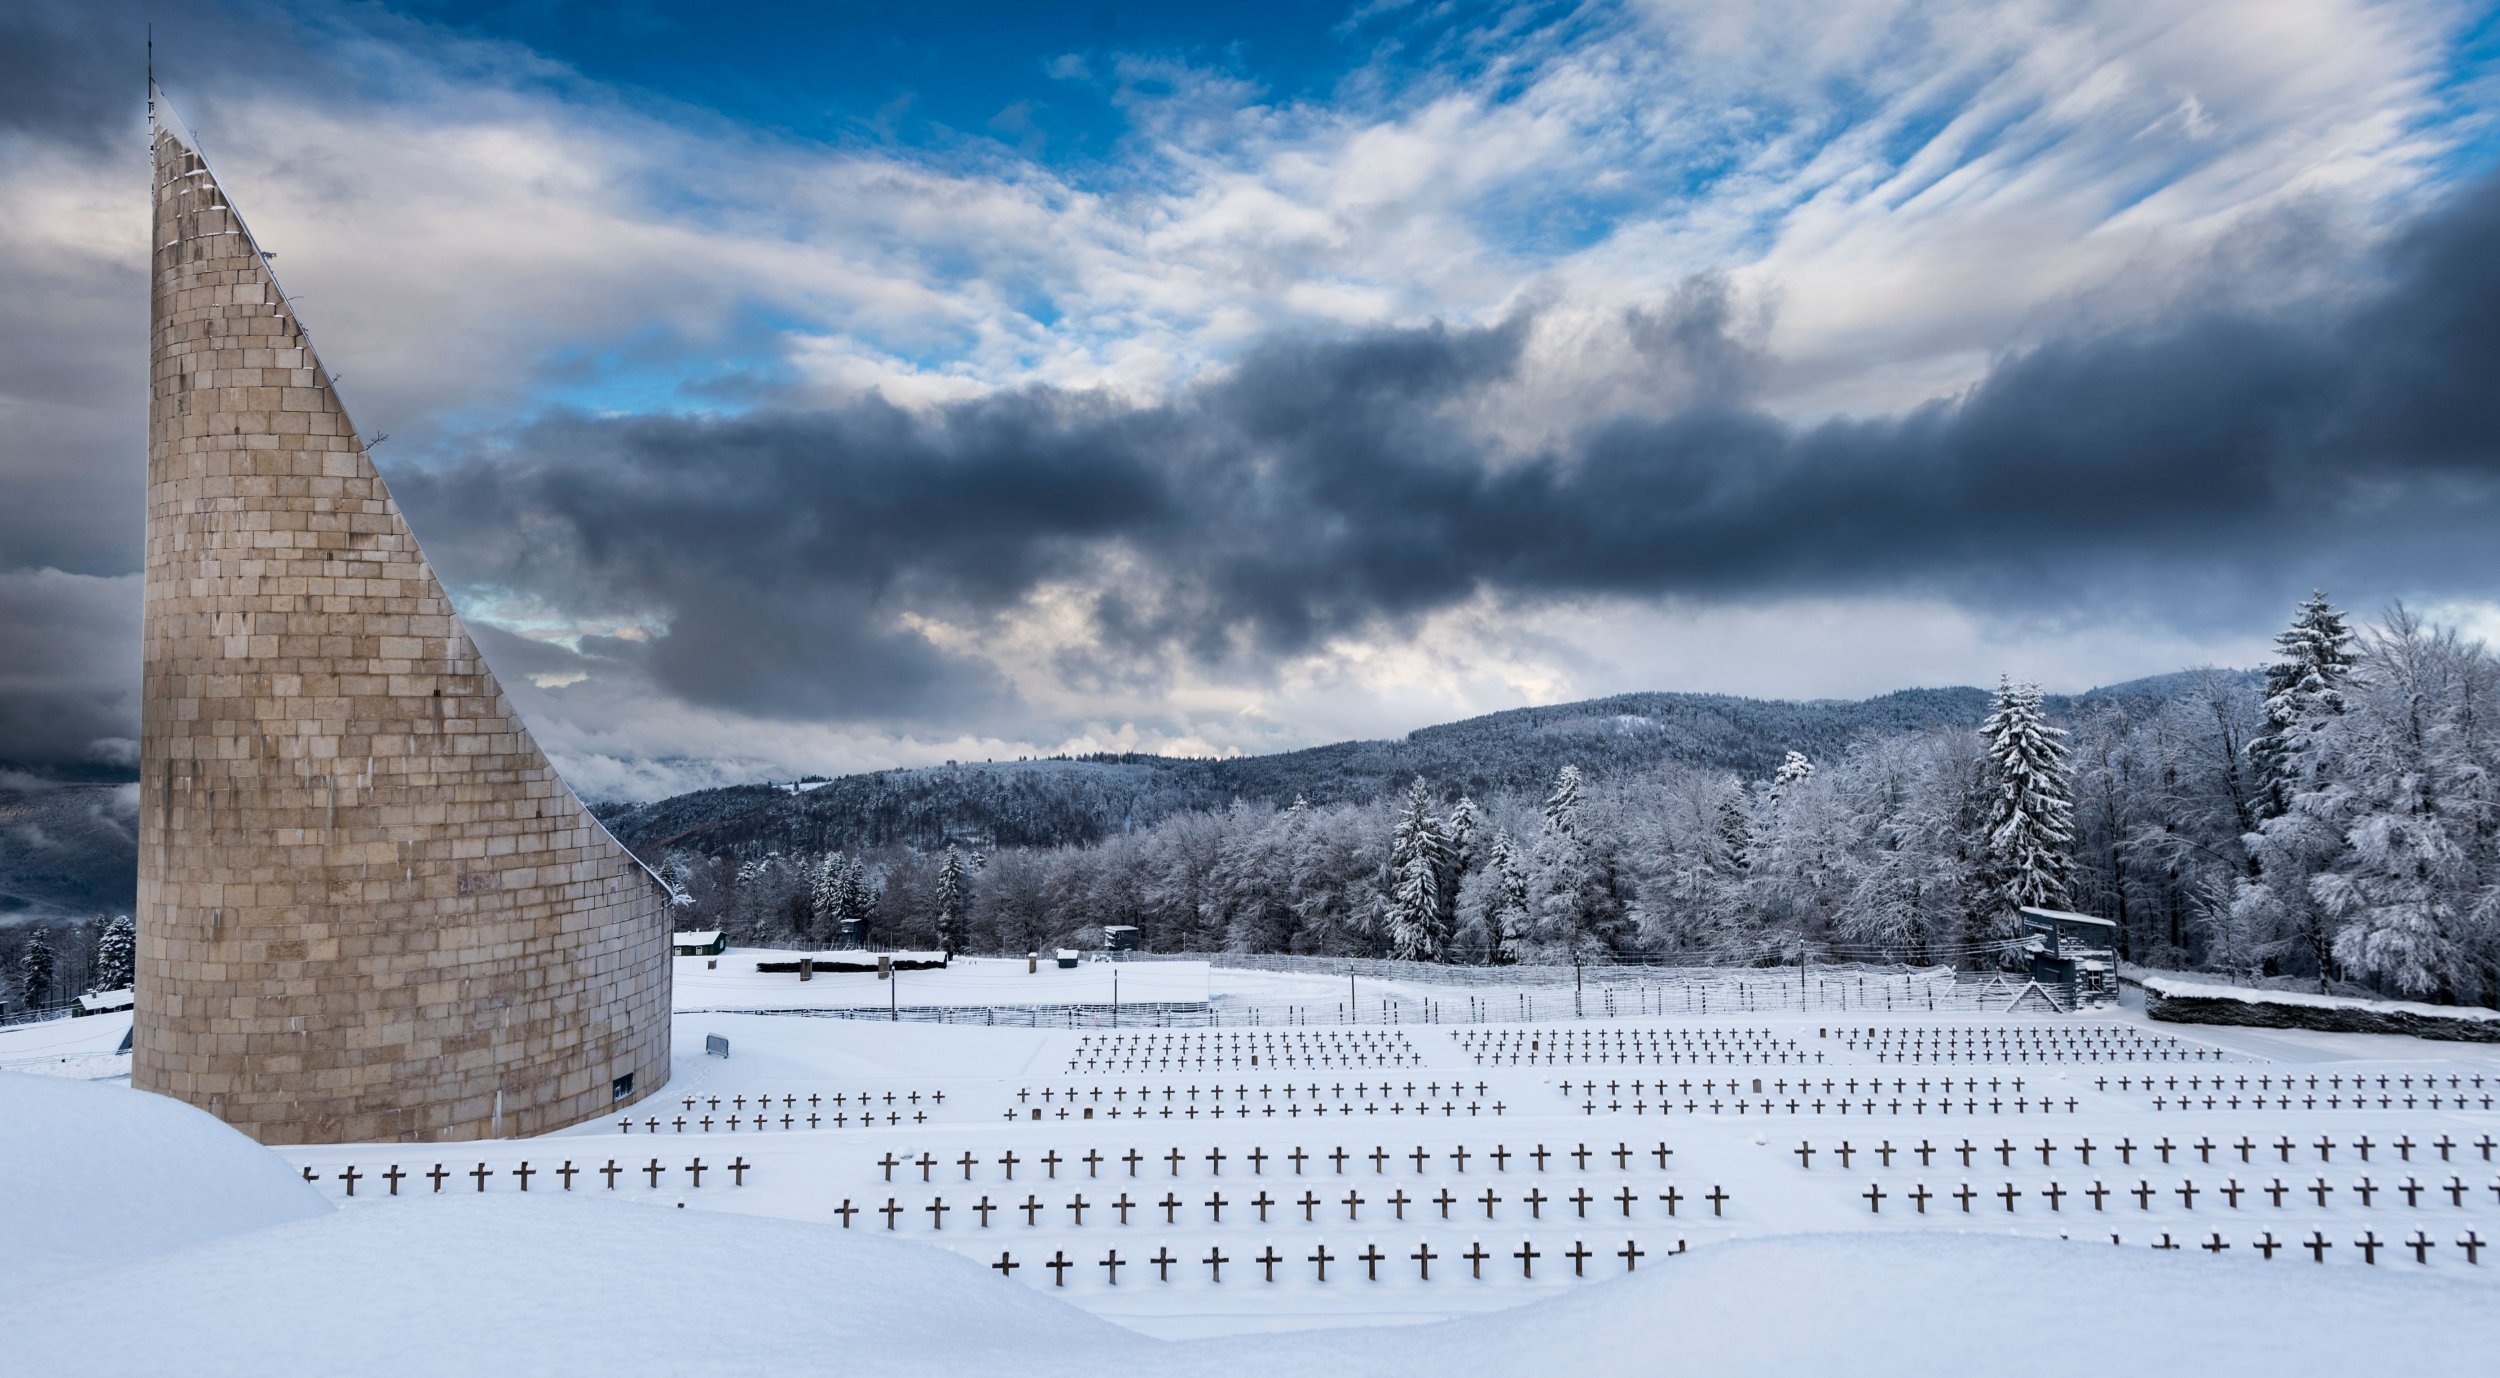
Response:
[0,0,2500,798]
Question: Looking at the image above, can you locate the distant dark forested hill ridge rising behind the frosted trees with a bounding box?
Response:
[600,673,2230,863]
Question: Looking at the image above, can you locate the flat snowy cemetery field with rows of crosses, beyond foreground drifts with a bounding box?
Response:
[248,1015,2500,1338]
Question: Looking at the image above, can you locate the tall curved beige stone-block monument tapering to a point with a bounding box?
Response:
[130,96,670,1143]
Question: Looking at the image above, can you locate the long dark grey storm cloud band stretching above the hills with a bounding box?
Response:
[403,171,2500,715]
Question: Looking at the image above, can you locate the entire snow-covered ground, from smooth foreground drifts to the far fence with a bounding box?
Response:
[0,958,2500,1373]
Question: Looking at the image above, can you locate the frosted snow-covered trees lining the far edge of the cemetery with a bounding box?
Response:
[658,598,2500,1003]
